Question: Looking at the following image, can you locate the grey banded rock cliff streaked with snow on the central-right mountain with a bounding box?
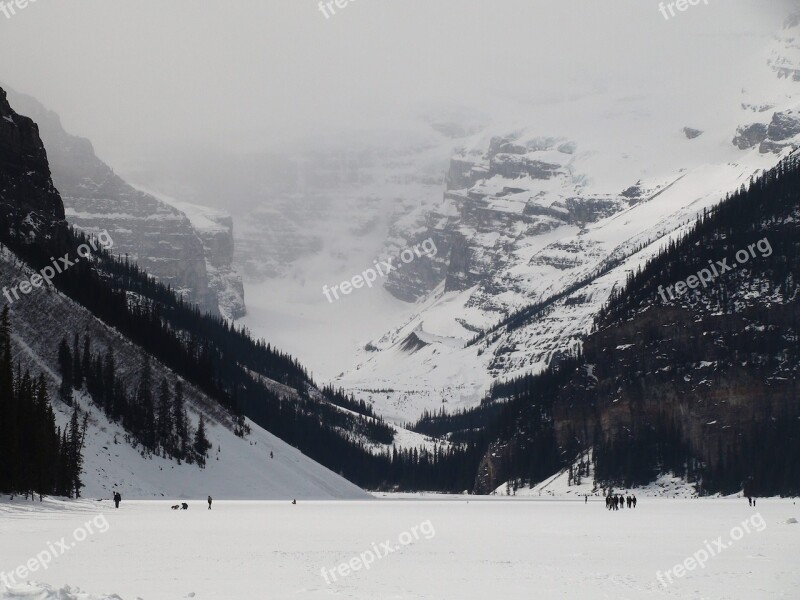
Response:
[386,137,633,303]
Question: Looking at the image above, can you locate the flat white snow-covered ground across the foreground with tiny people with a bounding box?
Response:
[0,497,800,600]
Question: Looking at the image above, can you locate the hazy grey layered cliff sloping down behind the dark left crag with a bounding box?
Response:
[3,92,219,314]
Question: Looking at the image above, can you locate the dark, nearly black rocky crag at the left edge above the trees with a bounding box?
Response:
[0,88,64,234]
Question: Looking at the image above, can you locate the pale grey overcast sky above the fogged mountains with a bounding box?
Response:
[0,0,797,166]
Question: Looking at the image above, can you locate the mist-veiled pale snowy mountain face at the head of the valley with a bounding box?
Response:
[228,115,482,379]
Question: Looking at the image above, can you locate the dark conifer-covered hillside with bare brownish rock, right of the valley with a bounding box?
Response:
[444,156,800,495]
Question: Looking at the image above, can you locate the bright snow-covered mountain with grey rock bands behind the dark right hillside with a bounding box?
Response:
[335,12,800,421]
